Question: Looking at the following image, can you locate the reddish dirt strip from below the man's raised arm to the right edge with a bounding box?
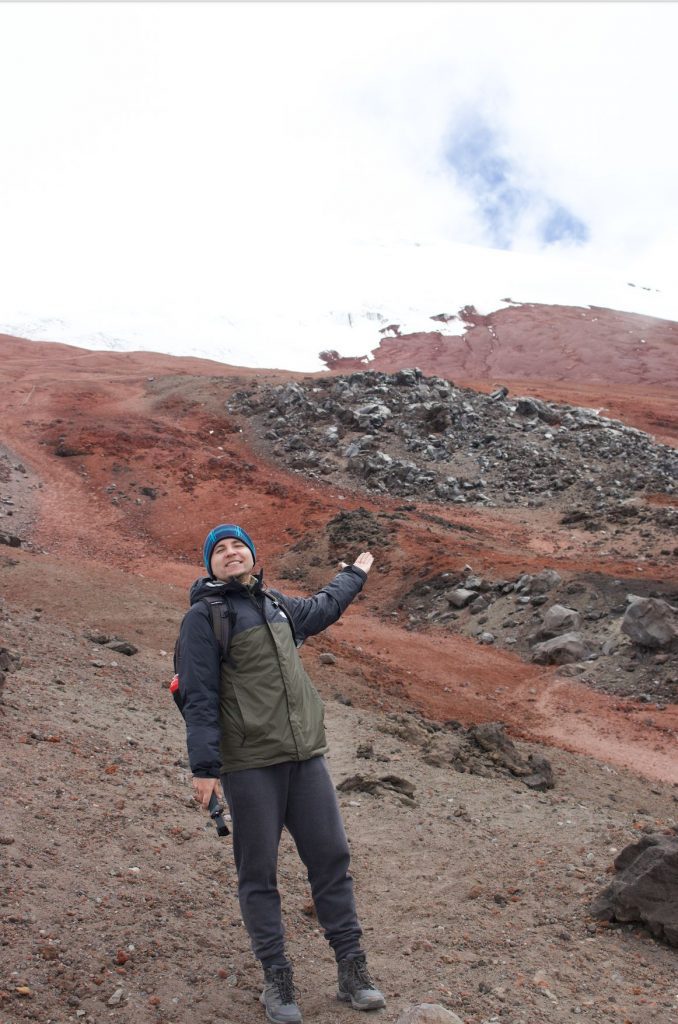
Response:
[333,614,678,783]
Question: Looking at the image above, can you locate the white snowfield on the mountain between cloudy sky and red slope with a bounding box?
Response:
[0,243,678,371]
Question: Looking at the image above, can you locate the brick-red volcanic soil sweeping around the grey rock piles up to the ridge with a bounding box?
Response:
[0,323,678,780]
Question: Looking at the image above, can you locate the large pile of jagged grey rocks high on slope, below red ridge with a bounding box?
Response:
[228,368,678,516]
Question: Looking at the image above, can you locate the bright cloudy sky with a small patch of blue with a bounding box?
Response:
[0,2,678,337]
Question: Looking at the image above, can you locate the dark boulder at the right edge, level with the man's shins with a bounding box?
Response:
[591,835,678,946]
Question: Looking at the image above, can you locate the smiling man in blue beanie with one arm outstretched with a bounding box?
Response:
[177,523,385,1024]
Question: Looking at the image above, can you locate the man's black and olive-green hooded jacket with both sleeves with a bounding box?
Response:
[177,565,367,778]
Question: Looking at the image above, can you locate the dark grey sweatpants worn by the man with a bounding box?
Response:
[221,757,363,968]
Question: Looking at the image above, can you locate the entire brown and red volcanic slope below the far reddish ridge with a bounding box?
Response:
[0,321,678,1024]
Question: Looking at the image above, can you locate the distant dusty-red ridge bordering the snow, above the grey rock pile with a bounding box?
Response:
[331,303,678,444]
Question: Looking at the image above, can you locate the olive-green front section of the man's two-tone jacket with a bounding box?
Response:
[220,622,328,773]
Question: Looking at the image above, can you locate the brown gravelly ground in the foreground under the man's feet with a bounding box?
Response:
[0,589,678,1024]
